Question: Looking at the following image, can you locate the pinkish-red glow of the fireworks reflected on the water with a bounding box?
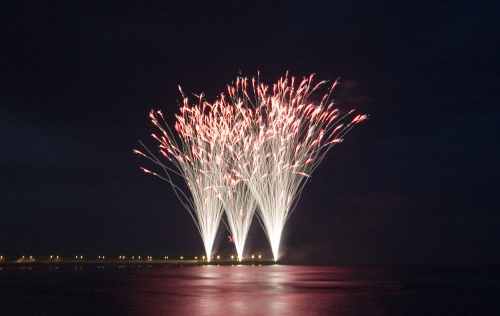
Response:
[125,266,394,315]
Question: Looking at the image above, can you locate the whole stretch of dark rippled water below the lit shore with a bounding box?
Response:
[0,266,500,316]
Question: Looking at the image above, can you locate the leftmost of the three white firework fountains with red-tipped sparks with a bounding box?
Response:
[134,91,225,261]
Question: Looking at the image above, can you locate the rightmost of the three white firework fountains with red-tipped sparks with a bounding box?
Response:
[229,75,367,260]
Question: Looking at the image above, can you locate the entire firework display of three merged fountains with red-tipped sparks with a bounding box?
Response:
[134,73,368,261]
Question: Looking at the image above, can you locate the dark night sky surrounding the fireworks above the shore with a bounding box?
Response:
[0,0,500,264]
